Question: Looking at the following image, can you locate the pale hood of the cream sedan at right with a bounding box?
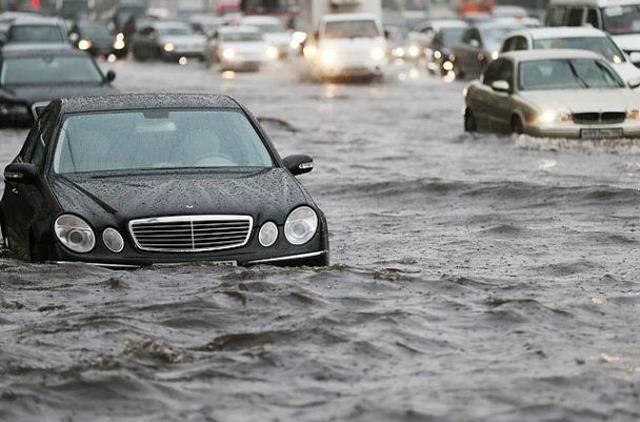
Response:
[521,89,638,113]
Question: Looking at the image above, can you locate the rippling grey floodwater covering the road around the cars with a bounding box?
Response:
[0,62,640,421]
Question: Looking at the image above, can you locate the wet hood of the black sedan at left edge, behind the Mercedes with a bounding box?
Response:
[0,84,118,106]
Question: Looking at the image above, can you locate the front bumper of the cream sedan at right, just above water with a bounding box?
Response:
[525,121,640,140]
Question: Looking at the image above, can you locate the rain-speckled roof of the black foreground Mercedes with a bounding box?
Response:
[56,94,241,113]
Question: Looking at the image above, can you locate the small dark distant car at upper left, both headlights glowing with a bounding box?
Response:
[69,22,125,57]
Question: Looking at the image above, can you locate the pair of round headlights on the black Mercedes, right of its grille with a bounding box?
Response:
[258,205,318,248]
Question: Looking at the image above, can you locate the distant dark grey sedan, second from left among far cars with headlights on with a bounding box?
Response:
[131,21,208,61]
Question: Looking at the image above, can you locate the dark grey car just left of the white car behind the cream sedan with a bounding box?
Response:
[451,20,525,79]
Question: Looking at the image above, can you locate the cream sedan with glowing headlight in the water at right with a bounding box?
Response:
[464,50,640,140]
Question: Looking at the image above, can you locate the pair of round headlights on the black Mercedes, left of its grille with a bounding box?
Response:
[54,214,124,253]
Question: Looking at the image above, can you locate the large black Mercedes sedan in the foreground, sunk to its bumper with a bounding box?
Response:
[0,95,329,267]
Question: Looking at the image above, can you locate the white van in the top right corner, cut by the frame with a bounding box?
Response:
[547,0,640,65]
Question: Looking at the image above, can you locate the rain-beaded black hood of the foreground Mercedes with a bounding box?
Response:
[51,168,310,224]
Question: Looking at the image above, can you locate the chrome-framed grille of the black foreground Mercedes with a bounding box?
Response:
[129,215,253,253]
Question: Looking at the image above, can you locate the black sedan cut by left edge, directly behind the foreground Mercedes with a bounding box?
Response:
[0,46,116,126]
